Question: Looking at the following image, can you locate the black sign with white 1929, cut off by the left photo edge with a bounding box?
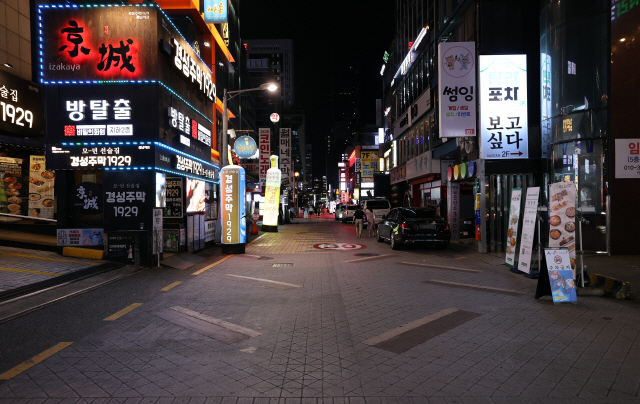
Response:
[0,70,44,138]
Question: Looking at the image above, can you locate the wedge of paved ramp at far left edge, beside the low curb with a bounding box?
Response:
[0,246,104,292]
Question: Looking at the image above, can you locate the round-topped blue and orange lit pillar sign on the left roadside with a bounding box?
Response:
[221,166,247,244]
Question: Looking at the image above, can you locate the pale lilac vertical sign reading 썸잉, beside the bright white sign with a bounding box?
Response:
[438,42,477,137]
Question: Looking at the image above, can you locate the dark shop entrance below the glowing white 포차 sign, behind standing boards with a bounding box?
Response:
[486,174,535,253]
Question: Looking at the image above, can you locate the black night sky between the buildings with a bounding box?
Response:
[239,0,395,177]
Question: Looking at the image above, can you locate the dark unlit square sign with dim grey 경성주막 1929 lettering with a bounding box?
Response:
[102,171,155,232]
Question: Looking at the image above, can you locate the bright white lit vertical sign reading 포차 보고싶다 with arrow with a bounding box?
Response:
[480,55,529,159]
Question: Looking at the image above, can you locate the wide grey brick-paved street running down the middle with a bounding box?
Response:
[0,219,640,404]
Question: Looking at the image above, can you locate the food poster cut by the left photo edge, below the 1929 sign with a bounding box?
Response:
[0,157,28,215]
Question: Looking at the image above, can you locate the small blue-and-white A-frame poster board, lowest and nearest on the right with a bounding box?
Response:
[544,248,578,304]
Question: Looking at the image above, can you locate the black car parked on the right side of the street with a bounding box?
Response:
[377,208,451,250]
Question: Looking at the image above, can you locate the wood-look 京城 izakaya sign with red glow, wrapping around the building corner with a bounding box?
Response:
[38,4,216,102]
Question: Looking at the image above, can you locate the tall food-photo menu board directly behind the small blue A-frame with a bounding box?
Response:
[549,182,576,269]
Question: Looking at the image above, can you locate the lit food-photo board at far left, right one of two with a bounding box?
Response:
[29,156,56,219]
